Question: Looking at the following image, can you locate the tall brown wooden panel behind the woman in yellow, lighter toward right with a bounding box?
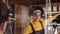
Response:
[14,5,29,34]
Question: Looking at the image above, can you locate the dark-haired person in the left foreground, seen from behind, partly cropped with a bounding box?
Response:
[0,1,9,34]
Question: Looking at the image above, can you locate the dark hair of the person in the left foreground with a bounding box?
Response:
[0,1,9,25]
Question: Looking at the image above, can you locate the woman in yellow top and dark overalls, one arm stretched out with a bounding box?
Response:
[24,7,59,34]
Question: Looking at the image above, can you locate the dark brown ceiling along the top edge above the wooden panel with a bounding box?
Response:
[3,0,60,5]
